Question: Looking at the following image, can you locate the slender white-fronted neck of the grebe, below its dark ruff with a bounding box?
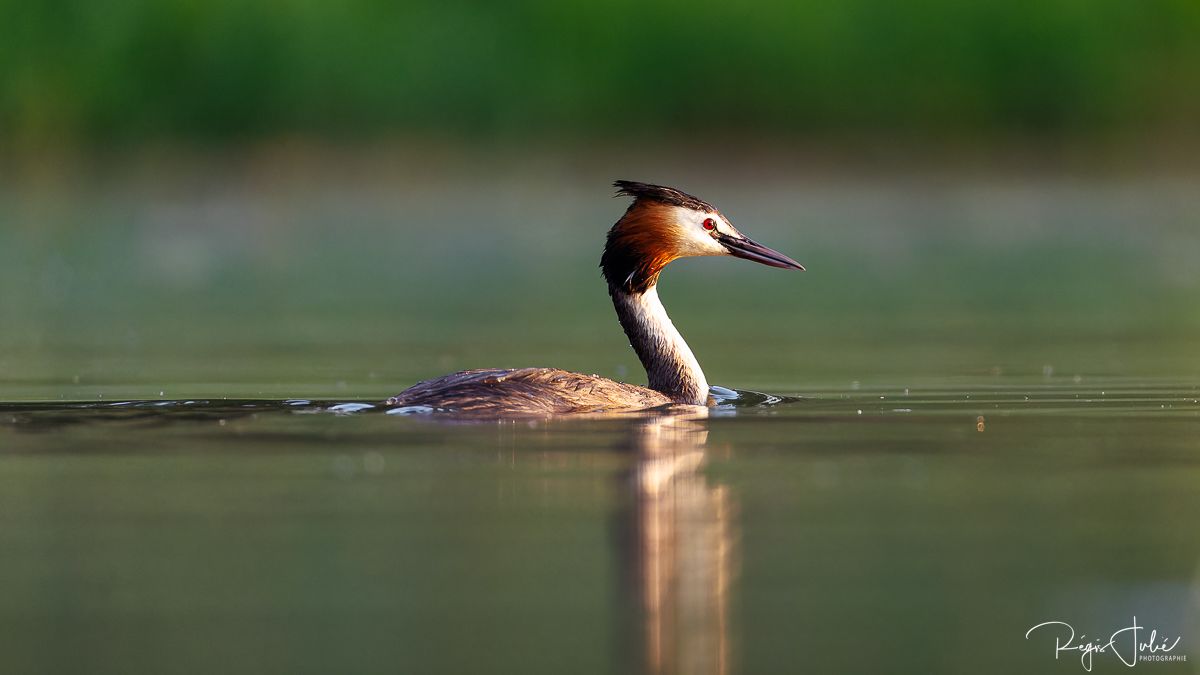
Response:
[608,285,708,406]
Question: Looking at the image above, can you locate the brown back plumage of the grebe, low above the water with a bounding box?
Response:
[386,368,671,416]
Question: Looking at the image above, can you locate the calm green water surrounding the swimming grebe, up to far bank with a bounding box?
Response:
[0,165,1200,674]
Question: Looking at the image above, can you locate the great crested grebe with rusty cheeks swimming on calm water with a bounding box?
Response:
[386,180,804,414]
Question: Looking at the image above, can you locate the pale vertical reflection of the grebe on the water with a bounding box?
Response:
[622,406,736,674]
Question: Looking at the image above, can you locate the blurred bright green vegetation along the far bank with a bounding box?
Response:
[0,0,1200,147]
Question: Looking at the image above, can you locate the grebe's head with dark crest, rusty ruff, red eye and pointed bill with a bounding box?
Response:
[600,180,804,293]
